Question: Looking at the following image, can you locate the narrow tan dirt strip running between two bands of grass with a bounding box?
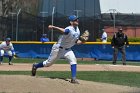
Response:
[0,63,140,72]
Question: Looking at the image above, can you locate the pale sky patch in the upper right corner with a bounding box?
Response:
[100,0,140,13]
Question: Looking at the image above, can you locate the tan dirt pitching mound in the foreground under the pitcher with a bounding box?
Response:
[0,75,139,93]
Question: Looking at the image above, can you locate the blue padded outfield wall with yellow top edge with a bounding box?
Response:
[13,42,140,61]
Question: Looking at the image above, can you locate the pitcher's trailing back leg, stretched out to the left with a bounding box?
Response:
[32,44,59,76]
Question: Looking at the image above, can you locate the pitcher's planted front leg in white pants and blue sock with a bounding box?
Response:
[64,50,78,84]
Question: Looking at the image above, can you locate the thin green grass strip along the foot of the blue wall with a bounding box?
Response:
[4,58,140,66]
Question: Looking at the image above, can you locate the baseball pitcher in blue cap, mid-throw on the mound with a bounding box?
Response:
[32,15,89,84]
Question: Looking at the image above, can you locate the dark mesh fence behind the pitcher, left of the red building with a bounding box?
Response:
[0,11,99,41]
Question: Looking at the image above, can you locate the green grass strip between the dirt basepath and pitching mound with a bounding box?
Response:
[0,71,140,87]
